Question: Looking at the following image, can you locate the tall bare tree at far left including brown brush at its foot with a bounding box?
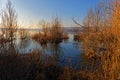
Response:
[0,1,18,54]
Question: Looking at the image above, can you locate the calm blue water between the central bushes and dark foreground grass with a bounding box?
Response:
[16,34,81,65]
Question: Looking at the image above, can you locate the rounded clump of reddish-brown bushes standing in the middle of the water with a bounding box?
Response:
[32,17,69,44]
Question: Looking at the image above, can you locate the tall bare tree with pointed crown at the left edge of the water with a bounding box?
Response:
[1,0,18,54]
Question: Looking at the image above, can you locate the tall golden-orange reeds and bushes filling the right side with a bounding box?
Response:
[73,0,120,80]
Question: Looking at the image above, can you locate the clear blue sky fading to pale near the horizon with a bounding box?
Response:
[1,0,100,27]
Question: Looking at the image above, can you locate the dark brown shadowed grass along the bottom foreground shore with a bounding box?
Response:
[0,51,105,80]
